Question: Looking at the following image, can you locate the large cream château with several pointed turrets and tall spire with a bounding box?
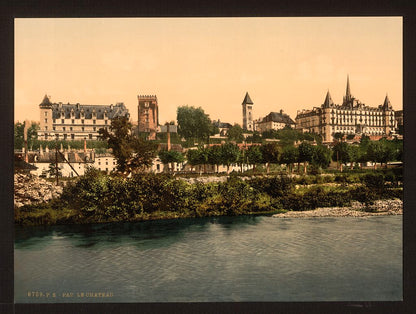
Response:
[296,77,396,142]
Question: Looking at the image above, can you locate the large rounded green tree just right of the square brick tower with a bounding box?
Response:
[176,106,215,143]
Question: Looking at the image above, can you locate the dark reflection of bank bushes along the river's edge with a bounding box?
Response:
[15,216,262,249]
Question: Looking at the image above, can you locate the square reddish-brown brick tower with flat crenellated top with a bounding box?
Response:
[137,95,159,140]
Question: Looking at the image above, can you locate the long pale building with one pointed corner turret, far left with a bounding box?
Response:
[38,95,130,140]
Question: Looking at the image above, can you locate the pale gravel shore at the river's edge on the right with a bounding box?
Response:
[273,199,403,218]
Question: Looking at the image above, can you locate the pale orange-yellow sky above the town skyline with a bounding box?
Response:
[14,17,403,125]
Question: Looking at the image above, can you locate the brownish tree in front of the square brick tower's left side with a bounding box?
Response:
[98,117,157,173]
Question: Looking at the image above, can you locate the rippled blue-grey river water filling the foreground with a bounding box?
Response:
[15,216,402,303]
